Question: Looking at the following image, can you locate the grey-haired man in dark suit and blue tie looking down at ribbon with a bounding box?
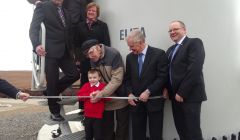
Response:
[126,30,168,140]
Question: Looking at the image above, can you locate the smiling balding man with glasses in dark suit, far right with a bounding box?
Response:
[167,21,207,140]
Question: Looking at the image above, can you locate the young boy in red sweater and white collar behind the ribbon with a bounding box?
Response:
[77,69,109,140]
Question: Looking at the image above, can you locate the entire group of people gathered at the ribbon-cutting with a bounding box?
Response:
[5,0,207,140]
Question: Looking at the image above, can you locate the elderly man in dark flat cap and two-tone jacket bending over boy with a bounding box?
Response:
[82,39,129,140]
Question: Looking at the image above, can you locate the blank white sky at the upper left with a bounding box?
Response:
[0,0,34,71]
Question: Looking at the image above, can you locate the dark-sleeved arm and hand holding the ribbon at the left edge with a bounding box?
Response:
[0,78,29,101]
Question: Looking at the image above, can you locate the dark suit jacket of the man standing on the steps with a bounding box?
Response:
[29,1,71,58]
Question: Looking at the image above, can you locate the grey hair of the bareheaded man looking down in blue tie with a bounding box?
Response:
[126,29,145,43]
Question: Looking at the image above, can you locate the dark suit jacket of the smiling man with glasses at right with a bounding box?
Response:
[167,37,207,102]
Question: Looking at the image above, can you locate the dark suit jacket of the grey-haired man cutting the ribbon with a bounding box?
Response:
[126,46,168,111]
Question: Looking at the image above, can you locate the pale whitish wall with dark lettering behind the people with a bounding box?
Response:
[96,0,240,140]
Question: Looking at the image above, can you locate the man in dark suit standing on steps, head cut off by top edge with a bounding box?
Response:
[29,0,79,121]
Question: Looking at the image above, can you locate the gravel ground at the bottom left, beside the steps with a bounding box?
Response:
[0,98,78,140]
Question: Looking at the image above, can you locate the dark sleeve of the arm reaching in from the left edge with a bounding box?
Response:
[0,79,19,98]
